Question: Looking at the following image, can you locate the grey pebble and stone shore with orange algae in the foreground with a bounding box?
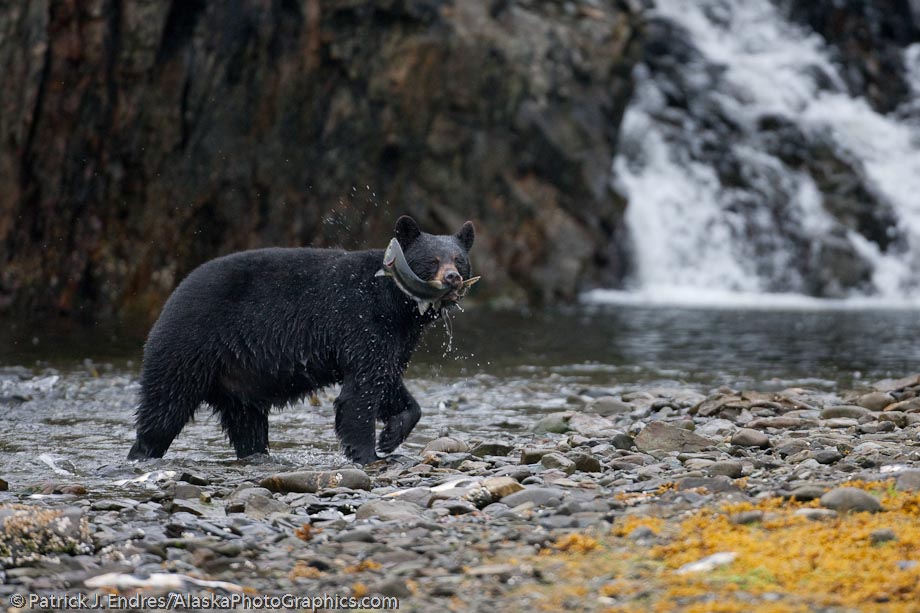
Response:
[0,376,920,611]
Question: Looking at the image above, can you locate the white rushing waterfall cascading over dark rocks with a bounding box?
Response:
[586,0,920,308]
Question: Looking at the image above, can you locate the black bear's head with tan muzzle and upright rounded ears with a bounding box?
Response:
[396,215,476,301]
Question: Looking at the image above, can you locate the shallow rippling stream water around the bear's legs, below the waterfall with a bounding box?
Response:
[0,306,920,496]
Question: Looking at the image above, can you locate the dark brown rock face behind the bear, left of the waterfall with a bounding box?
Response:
[0,0,638,316]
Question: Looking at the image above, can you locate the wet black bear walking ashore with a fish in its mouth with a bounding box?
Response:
[128,216,474,464]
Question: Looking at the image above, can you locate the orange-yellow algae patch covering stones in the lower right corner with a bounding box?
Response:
[496,482,920,613]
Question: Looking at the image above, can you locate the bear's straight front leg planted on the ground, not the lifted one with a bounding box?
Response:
[334,376,386,464]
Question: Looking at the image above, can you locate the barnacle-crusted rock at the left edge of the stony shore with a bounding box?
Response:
[0,504,95,566]
